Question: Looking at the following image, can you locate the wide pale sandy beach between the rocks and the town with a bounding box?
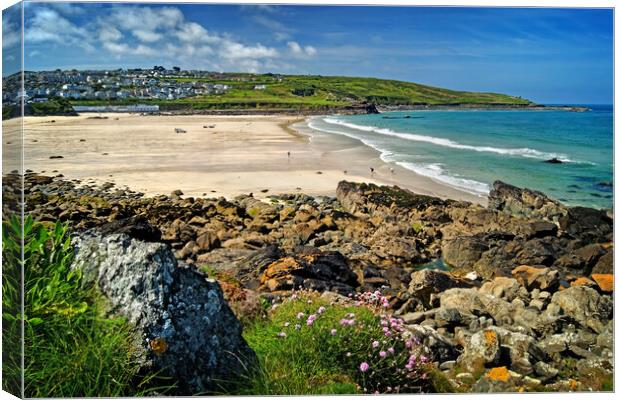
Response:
[2,114,486,204]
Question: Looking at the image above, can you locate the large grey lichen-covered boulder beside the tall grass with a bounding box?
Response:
[73,232,256,395]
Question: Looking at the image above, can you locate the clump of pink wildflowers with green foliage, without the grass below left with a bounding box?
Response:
[266,291,430,393]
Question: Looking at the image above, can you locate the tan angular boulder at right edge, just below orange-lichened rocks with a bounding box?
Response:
[551,286,613,333]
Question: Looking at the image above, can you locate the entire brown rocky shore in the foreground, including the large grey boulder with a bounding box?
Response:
[3,173,613,393]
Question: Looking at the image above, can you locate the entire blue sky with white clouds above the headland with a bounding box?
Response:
[3,3,613,103]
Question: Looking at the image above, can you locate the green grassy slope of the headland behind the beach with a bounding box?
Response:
[71,74,532,110]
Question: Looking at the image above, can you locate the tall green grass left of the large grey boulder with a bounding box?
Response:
[2,217,170,397]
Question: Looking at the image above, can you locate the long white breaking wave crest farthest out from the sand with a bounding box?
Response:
[323,118,573,162]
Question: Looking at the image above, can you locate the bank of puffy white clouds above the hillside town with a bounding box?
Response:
[21,5,317,72]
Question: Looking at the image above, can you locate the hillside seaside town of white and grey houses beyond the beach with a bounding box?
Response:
[2,65,282,105]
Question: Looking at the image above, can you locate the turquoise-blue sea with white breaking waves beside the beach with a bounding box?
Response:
[309,105,613,208]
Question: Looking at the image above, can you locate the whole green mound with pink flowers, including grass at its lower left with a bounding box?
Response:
[242,292,429,395]
